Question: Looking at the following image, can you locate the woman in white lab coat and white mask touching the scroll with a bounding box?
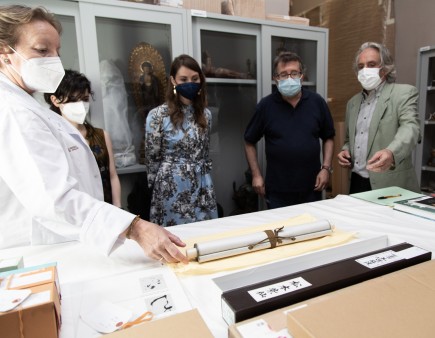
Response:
[0,5,187,262]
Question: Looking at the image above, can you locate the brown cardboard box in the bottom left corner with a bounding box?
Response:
[0,283,61,338]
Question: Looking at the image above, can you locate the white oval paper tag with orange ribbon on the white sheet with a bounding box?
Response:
[80,301,132,333]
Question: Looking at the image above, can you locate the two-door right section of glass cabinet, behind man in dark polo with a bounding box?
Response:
[191,13,328,216]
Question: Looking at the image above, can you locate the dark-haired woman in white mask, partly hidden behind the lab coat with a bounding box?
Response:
[44,69,121,207]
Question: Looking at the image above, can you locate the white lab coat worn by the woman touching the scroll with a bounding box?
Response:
[0,73,134,254]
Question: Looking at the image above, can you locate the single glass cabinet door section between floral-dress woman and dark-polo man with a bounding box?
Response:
[192,17,262,216]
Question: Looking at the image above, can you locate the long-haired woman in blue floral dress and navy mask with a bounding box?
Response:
[145,54,217,226]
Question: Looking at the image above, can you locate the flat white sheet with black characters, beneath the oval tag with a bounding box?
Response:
[60,267,192,338]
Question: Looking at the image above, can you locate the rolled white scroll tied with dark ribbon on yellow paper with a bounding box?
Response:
[186,220,334,263]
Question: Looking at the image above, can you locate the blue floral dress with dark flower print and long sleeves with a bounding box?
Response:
[145,104,217,226]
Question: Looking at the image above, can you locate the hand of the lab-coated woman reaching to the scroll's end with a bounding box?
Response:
[130,219,189,264]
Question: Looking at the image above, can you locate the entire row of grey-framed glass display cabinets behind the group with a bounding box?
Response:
[19,0,328,211]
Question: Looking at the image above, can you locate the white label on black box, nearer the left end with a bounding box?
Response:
[248,277,311,302]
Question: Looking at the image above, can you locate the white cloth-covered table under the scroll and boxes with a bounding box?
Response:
[0,195,435,338]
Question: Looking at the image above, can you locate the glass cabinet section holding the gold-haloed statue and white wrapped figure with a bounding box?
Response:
[79,0,187,174]
